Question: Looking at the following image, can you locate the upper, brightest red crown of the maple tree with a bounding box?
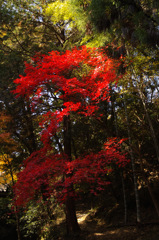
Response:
[14,47,118,138]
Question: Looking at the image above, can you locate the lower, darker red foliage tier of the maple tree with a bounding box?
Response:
[15,139,128,205]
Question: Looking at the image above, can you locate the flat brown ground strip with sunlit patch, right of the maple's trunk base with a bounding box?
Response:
[73,211,159,240]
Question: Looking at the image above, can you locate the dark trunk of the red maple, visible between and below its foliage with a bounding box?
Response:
[64,116,80,235]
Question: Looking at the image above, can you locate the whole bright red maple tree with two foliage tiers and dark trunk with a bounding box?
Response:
[14,46,127,232]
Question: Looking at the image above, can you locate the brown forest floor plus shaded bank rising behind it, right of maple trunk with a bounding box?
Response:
[57,200,159,240]
